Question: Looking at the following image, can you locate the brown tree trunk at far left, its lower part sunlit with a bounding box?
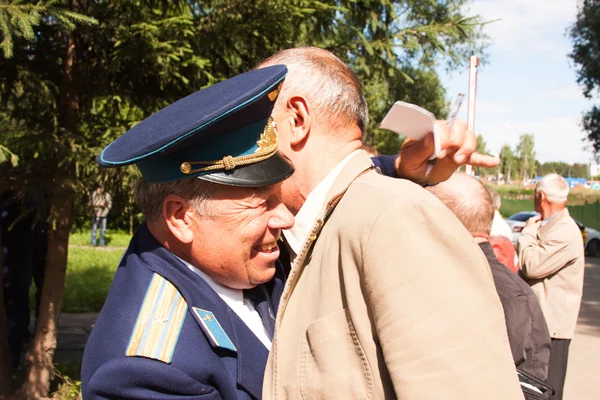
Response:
[22,181,73,398]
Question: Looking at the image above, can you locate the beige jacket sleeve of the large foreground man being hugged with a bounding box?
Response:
[362,202,523,400]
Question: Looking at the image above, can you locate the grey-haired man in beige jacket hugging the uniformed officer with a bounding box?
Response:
[263,48,522,400]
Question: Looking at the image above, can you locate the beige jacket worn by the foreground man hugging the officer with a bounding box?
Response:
[263,154,523,400]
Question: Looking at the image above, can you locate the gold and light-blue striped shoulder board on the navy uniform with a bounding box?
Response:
[125,273,188,364]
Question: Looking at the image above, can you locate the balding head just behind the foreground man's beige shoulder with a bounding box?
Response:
[427,173,494,235]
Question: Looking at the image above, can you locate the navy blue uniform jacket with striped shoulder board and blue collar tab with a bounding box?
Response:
[82,224,282,400]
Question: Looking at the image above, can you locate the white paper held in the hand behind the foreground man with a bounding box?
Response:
[380,101,440,157]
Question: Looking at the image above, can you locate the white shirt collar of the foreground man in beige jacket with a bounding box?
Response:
[283,150,362,259]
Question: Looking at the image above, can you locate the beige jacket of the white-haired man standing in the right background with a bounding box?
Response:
[519,208,585,339]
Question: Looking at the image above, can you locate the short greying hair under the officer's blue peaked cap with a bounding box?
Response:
[135,178,218,222]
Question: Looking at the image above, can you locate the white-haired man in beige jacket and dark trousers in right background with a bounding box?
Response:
[519,174,585,400]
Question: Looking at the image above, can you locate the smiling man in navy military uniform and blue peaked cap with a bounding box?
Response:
[82,65,293,399]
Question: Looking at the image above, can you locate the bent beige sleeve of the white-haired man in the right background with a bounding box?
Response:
[519,225,575,279]
